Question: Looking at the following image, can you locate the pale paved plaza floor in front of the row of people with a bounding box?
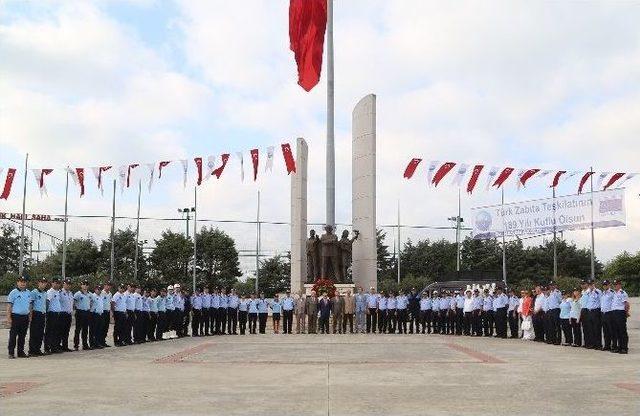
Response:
[0,330,640,416]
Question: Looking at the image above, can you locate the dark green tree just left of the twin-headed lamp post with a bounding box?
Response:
[149,230,193,287]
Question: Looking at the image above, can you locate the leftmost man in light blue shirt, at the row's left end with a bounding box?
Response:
[7,276,32,358]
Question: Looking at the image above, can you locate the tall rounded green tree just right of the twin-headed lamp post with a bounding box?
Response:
[196,227,242,288]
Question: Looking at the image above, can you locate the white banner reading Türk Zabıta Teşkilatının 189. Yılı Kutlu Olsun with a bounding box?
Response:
[471,189,626,239]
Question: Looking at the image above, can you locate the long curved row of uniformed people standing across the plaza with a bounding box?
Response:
[7,278,629,358]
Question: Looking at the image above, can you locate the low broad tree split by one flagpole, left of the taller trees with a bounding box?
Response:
[39,238,100,277]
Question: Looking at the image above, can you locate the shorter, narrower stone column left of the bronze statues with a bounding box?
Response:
[291,138,309,292]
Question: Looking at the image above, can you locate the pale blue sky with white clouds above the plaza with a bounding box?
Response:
[0,0,640,280]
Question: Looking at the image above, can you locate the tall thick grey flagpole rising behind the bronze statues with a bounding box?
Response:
[326,0,336,226]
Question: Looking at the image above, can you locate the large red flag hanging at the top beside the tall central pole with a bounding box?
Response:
[289,0,327,91]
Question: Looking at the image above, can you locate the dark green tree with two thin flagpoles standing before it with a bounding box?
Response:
[98,228,148,283]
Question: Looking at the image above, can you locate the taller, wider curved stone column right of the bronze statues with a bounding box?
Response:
[351,94,378,291]
